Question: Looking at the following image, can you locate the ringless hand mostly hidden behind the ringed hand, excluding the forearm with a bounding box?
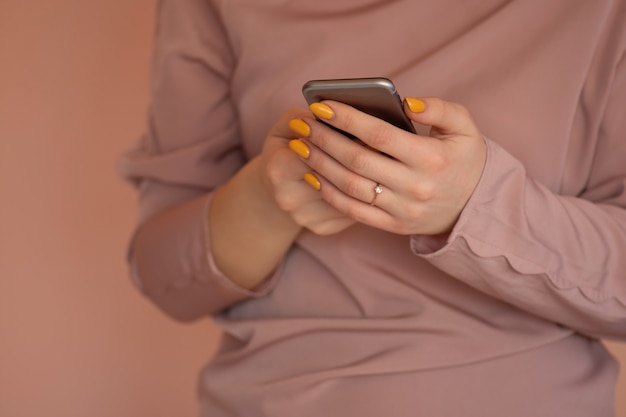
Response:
[260,108,354,235]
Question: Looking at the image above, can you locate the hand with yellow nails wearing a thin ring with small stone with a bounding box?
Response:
[293,97,486,235]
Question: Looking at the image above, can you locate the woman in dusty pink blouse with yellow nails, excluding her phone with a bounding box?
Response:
[120,0,626,417]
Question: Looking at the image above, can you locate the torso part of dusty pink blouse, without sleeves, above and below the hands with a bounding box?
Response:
[200,0,615,417]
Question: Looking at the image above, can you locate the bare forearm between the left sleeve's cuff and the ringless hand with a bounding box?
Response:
[209,158,301,289]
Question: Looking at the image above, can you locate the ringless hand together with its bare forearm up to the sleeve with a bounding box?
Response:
[209,109,354,289]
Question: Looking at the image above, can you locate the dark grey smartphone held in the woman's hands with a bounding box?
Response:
[302,77,416,132]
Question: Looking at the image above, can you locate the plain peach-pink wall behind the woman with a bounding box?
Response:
[0,0,626,417]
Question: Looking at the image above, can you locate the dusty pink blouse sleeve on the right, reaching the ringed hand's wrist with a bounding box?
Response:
[411,53,626,339]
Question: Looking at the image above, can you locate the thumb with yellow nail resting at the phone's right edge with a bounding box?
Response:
[404,97,479,136]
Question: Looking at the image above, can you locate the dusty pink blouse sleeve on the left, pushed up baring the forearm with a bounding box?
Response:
[118,0,272,320]
